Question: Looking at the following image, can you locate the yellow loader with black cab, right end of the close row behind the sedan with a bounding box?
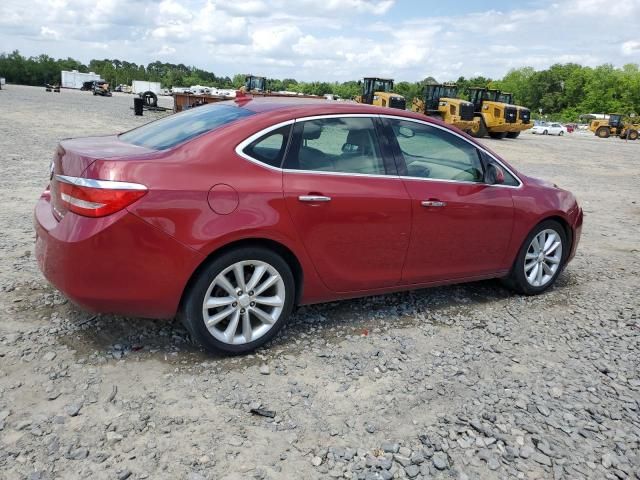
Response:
[469,87,533,138]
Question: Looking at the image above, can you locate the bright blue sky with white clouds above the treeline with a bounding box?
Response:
[0,0,640,81]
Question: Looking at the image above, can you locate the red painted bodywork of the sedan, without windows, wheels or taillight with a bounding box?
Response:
[35,98,582,352]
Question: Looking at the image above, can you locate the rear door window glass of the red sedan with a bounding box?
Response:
[285,117,385,175]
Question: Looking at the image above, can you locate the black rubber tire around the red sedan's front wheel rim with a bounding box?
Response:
[504,220,569,295]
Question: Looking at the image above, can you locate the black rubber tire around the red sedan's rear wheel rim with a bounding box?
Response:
[179,247,296,355]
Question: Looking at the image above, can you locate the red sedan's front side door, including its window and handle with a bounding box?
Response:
[384,119,519,284]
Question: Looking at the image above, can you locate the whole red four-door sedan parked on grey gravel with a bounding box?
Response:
[35,97,582,353]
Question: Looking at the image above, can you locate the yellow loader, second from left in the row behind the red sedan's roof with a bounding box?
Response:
[411,83,479,132]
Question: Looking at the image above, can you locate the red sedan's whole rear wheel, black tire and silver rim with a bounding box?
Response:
[181,247,295,354]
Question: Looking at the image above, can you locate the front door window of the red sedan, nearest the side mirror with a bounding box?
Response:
[391,120,484,182]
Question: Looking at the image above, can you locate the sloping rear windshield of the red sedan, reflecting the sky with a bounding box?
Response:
[119,105,254,150]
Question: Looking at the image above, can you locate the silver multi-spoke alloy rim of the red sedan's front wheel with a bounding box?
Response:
[524,228,562,287]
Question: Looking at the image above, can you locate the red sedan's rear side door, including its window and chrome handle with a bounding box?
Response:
[283,116,411,292]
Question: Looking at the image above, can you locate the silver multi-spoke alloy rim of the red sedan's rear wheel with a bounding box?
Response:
[202,260,286,345]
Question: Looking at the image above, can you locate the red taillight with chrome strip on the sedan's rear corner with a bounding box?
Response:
[55,175,147,217]
